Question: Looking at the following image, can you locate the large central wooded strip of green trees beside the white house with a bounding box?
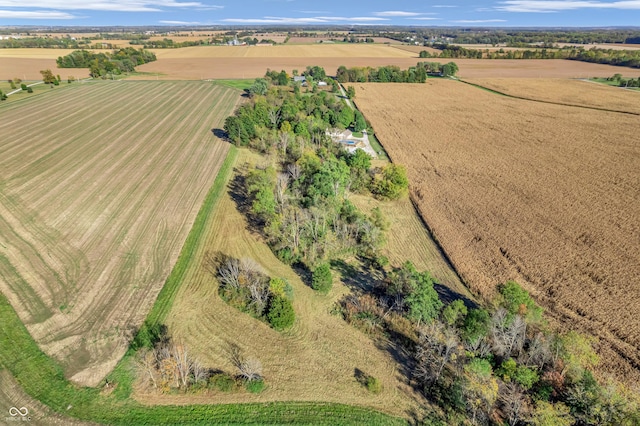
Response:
[224,77,408,270]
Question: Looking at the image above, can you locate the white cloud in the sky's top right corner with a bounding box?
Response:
[496,0,640,13]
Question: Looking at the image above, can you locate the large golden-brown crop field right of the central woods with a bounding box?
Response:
[356,80,640,381]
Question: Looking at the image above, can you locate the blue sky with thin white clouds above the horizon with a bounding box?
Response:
[0,0,640,27]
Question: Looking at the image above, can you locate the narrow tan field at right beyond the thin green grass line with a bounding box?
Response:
[465,78,640,115]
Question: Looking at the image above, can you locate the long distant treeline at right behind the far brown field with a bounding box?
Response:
[419,44,640,68]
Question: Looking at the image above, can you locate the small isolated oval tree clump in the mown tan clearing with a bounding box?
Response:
[217,258,295,331]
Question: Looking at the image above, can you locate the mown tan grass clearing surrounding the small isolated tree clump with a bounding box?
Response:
[156,150,420,417]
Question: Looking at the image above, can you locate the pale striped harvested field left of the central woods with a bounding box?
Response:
[0,81,238,385]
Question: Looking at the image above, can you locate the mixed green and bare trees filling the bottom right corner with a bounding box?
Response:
[340,274,640,426]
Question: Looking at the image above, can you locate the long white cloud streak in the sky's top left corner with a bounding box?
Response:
[0,0,210,12]
